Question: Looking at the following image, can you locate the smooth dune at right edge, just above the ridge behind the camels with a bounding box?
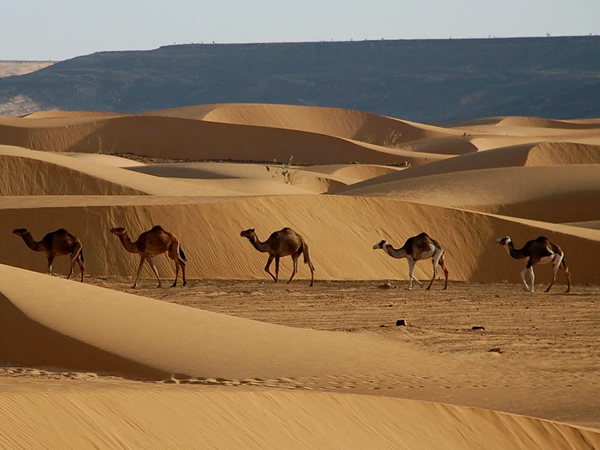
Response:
[338,164,600,223]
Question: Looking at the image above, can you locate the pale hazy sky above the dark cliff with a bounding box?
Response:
[0,0,600,61]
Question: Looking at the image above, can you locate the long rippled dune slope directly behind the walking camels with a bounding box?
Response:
[0,195,600,283]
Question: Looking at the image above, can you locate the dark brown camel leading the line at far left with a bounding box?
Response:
[13,228,85,283]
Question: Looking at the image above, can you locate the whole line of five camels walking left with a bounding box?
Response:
[13,225,571,293]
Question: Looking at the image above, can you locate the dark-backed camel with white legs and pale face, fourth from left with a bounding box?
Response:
[373,233,448,291]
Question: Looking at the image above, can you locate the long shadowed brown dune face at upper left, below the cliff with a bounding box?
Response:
[0,106,446,165]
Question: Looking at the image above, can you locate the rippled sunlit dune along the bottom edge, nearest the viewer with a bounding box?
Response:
[0,387,600,450]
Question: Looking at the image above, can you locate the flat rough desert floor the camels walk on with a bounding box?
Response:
[79,279,600,428]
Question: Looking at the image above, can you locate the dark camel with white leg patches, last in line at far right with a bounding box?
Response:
[496,236,571,293]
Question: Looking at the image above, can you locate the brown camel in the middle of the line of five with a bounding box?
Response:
[240,228,315,286]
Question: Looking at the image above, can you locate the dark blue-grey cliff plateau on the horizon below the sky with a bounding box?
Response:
[0,36,600,123]
